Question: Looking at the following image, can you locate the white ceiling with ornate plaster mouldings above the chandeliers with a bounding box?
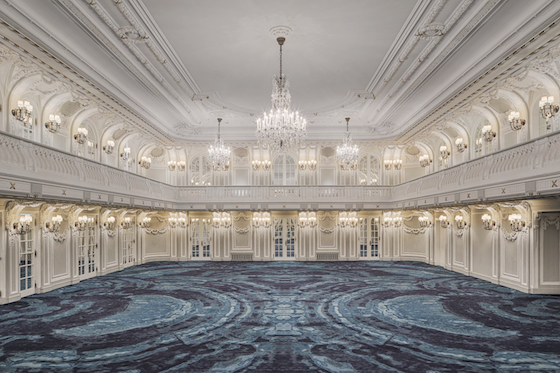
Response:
[0,0,560,143]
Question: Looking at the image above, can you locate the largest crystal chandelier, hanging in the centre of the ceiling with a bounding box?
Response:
[256,27,307,152]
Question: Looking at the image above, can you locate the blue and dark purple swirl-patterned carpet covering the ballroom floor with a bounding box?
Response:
[0,262,560,373]
